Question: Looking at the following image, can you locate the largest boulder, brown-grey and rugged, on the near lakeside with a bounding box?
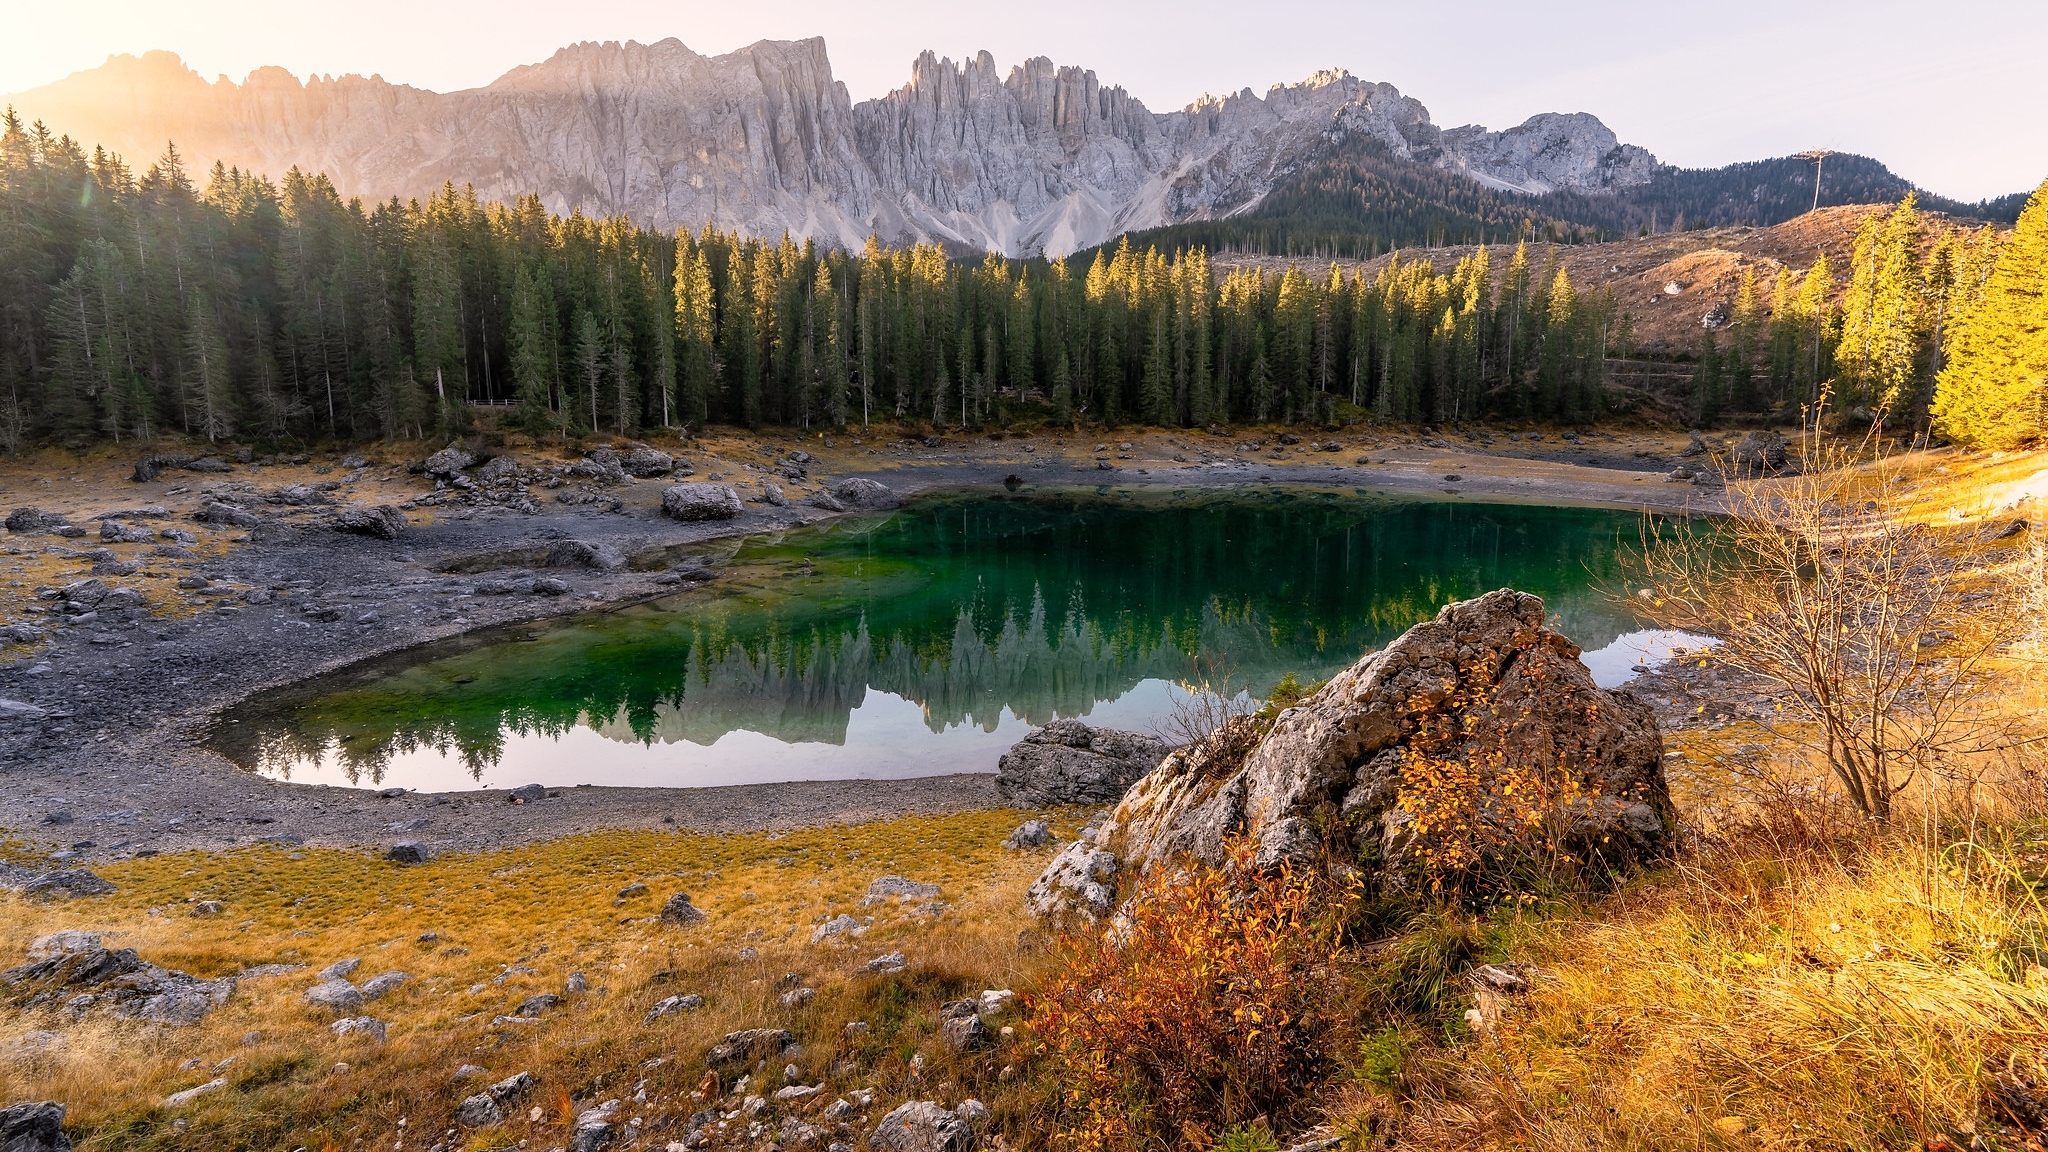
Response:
[1028,588,1675,918]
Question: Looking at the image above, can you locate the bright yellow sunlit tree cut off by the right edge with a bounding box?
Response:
[1933,180,2048,449]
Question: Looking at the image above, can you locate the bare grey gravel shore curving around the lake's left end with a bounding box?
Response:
[0,437,1712,867]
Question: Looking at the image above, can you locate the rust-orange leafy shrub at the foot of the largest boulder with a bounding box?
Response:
[1032,840,1356,1152]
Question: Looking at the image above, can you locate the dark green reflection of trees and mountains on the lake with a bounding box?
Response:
[229,494,1632,781]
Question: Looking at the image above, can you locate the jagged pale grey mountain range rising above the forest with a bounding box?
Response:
[10,39,1655,258]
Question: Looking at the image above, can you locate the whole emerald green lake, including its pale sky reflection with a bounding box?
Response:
[219,490,1638,789]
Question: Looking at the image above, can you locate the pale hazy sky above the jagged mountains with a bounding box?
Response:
[0,0,2048,199]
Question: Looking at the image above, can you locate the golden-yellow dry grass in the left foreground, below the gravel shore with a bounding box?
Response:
[0,812,1071,1150]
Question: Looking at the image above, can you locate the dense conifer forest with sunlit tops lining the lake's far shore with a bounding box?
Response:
[0,115,2038,451]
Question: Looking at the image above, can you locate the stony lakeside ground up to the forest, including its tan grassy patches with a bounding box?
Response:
[0,420,1744,865]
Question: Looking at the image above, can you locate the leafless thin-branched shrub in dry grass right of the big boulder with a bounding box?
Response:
[1624,412,2030,820]
